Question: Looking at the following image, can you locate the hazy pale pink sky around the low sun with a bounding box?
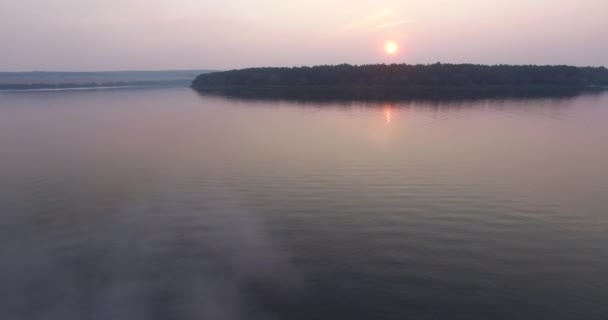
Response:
[0,0,608,71]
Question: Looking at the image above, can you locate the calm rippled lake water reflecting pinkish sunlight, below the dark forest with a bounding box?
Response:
[0,89,608,320]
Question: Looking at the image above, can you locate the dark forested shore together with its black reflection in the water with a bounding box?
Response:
[191,63,608,99]
